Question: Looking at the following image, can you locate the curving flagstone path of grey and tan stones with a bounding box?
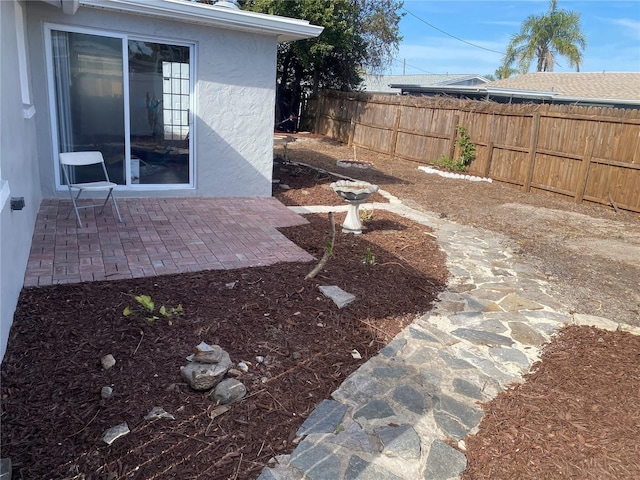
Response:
[259,192,634,480]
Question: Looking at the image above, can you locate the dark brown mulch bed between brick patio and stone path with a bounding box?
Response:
[1,205,448,479]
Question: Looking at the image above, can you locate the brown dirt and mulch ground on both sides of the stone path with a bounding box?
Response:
[0,136,640,480]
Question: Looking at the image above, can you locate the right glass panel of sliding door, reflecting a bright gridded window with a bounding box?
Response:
[128,40,191,184]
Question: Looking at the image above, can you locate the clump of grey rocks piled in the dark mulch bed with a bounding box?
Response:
[180,342,247,405]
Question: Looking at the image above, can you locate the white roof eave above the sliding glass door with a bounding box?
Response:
[43,0,323,42]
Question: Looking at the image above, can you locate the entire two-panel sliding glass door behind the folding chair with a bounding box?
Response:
[49,28,193,188]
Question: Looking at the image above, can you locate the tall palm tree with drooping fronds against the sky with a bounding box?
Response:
[500,0,587,76]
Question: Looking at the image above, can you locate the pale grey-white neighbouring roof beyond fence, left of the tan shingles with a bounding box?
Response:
[360,73,489,93]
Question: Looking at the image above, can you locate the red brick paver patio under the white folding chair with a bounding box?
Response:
[24,197,313,286]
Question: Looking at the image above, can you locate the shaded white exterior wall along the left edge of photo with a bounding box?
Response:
[0,1,46,359]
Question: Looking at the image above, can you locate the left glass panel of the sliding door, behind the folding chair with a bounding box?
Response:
[51,30,126,185]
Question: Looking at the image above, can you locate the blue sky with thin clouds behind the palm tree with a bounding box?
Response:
[384,0,640,75]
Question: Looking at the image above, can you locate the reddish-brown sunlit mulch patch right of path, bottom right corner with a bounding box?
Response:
[463,326,640,480]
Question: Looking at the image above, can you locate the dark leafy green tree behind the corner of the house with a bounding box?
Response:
[238,0,402,119]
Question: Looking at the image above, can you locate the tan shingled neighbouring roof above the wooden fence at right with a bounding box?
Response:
[484,72,640,101]
